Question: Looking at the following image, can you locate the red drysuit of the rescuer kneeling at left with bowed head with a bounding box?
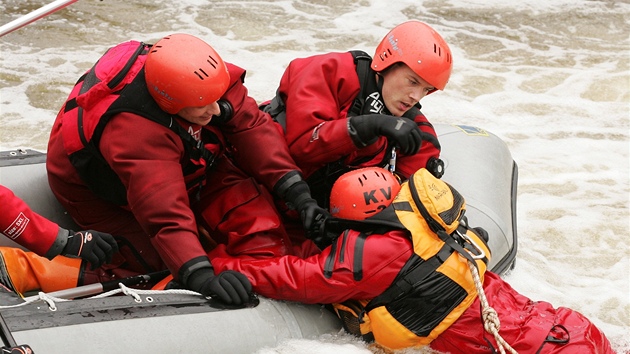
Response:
[47,56,298,283]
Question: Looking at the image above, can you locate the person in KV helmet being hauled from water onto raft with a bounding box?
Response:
[212,167,613,354]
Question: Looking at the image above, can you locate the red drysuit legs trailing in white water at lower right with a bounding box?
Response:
[431,272,614,354]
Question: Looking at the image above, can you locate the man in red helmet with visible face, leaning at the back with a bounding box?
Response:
[261,21,453,206]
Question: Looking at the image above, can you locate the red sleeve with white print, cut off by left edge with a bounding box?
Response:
[0,186,59,256]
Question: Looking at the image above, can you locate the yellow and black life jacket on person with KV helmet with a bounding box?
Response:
[334,169,490,350]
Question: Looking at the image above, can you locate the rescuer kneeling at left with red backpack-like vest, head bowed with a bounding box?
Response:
[41,34,326,304]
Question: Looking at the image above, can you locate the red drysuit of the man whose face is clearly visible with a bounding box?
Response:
[278,52,440,178]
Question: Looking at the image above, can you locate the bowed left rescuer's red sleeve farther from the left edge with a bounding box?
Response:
[221,64,299,190]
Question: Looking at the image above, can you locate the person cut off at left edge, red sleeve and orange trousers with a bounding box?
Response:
[0,185,118,296]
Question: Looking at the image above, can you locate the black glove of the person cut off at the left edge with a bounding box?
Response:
[61,230,118,270]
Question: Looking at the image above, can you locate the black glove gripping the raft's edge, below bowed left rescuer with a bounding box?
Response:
[187,268,252,305]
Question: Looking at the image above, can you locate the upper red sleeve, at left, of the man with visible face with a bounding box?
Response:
[279,52,359,171]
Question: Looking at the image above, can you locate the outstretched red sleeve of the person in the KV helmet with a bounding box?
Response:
[212,231,412,303]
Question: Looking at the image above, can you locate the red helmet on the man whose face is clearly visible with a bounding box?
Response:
[372,21,453,90]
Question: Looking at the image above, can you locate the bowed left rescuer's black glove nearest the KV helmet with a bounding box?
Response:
[284,180,330,232]
